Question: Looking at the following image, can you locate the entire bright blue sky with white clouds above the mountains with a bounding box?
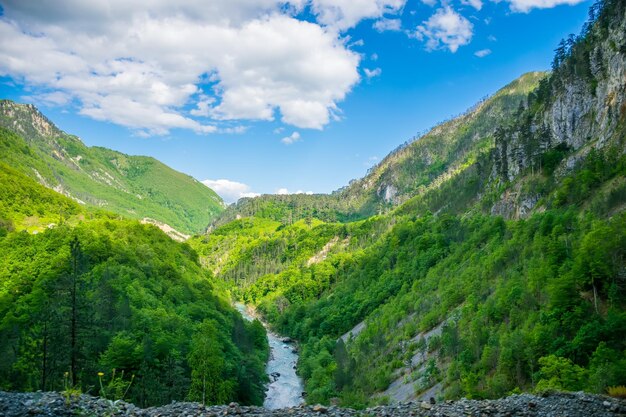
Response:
[0,0,590,203]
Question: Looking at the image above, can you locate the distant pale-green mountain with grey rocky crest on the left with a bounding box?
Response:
[0,100,224,234]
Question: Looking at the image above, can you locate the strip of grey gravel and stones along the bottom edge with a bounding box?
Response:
[0,391,626,417]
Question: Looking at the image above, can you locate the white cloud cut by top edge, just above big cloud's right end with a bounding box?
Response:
[311,0,406,31]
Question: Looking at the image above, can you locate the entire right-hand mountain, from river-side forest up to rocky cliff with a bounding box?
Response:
[189,0,626,407]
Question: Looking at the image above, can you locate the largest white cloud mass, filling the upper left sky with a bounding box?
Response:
[0,0,360,134]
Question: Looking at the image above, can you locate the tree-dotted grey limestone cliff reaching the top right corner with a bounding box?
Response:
[490,1,626,218]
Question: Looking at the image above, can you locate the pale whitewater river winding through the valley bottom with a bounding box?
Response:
[235,304,304,410]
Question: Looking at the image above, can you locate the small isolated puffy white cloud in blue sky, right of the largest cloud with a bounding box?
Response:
[415,6,473,53]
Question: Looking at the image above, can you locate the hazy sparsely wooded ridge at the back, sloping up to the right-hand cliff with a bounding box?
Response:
[208,72,546,226]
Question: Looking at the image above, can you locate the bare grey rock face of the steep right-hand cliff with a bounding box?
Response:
[492,6,626,185]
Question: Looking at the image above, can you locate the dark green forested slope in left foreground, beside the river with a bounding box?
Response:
[0,163,269,406]
